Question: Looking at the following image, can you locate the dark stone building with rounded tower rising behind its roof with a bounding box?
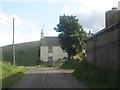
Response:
[86,4,120,71]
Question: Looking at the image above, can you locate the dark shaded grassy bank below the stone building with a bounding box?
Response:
[61,60,120,88]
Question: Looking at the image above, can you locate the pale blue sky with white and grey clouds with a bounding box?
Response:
[0,0,119,46]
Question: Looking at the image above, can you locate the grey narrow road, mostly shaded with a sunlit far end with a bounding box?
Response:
[12,67,85,88]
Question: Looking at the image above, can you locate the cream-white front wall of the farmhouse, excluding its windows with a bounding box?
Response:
[41,46,68,61]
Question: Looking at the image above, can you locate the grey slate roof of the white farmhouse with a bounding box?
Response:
[41,37,60,46]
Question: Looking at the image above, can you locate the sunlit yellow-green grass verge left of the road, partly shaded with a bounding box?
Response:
[2,63,26,88]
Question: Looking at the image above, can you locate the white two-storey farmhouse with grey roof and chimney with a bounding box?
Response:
[40,31,68,62]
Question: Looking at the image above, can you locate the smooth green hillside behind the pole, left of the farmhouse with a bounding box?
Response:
[2,41,40,66]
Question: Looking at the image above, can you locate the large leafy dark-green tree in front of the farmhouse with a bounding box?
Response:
[54,15,87,58]
